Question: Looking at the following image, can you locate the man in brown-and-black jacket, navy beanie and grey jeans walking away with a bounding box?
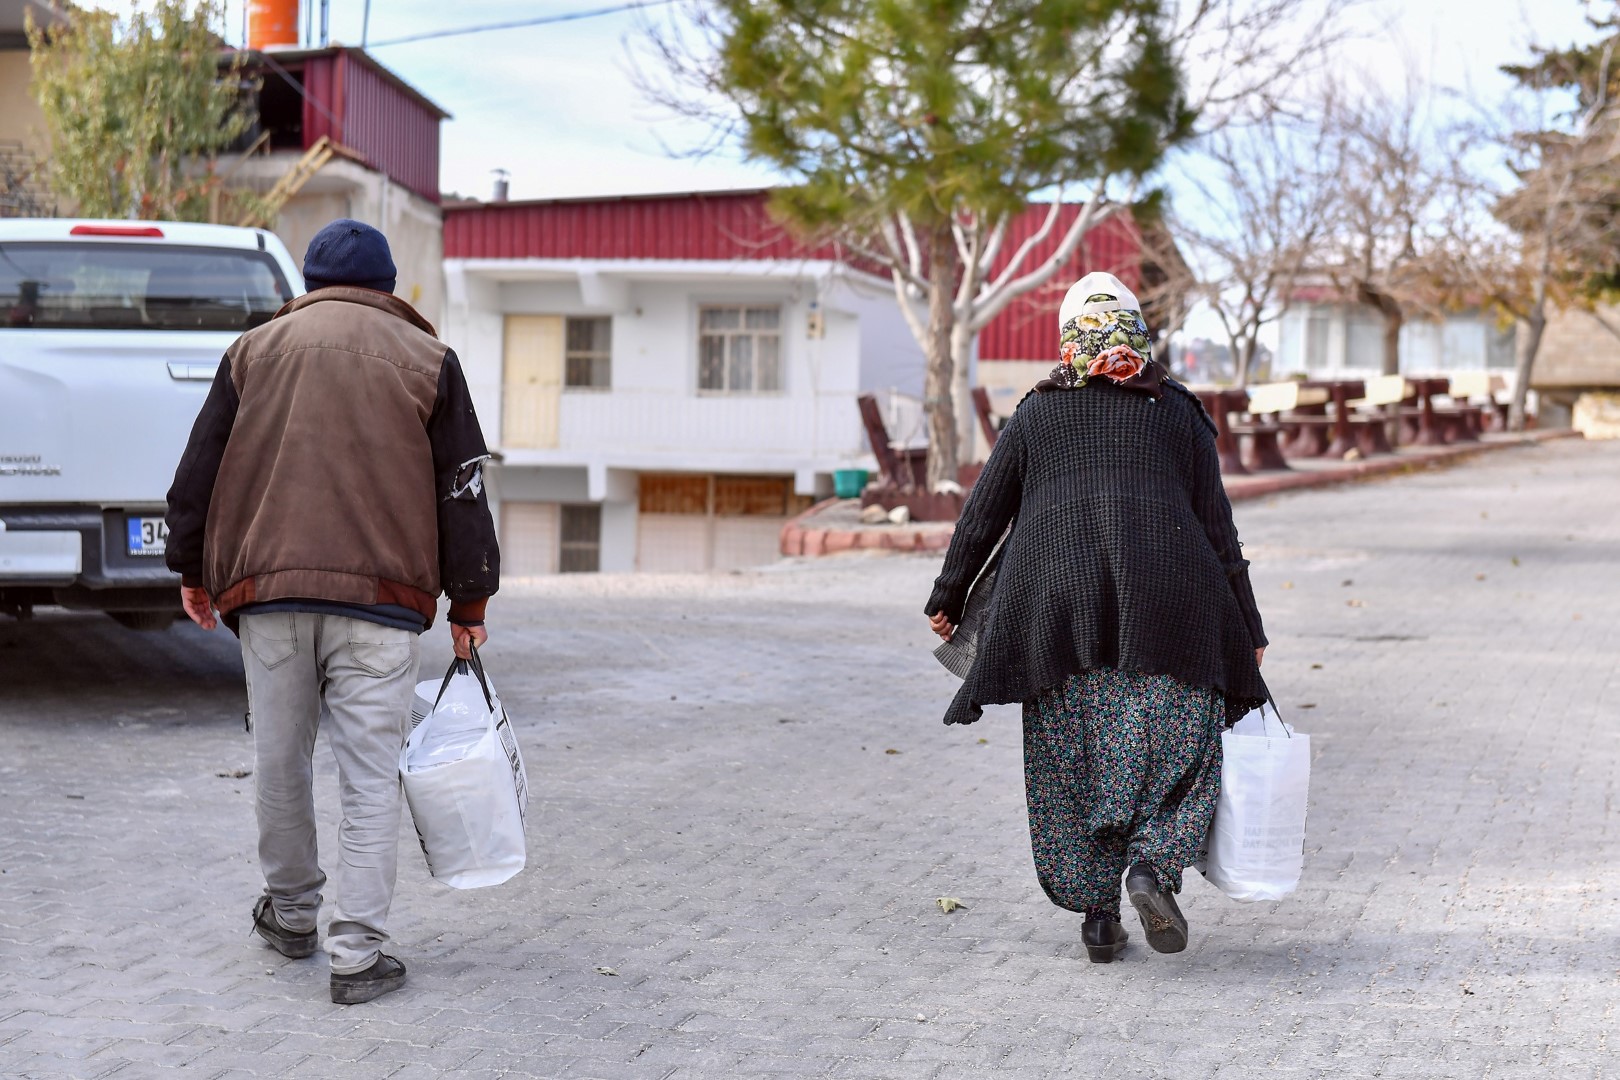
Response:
[168,219,499,1004]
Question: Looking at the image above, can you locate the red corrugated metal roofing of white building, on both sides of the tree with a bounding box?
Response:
[444,191,1142,359]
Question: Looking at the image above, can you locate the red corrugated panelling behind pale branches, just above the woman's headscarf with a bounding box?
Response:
[978,206,1142,363]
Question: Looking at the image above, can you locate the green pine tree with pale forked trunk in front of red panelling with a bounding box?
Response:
[666,0,1194,489]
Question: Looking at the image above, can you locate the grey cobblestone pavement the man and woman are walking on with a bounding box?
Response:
[0,440,1620,1080]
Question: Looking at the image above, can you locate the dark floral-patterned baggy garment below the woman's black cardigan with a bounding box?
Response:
[1024,667,1226,920]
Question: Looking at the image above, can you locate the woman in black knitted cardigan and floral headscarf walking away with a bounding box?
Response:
[927,274,1265,963]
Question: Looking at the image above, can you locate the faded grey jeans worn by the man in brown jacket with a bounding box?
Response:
[240,612,420,975]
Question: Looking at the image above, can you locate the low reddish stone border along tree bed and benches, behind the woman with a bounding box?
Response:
[779,429,1580,559]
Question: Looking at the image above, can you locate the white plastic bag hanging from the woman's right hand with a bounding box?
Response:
[1199,709,1311,902]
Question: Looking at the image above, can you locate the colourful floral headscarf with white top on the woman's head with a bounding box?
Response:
[1038,274,1163,400]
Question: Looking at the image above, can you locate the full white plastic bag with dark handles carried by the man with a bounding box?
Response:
[400,649,528,889]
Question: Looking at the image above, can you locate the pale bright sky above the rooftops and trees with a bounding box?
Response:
[186,0,1589,199]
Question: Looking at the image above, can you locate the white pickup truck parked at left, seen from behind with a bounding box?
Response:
[0,220,303,630]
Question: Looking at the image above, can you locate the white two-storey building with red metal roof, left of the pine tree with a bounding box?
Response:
[441,193,923,576]
